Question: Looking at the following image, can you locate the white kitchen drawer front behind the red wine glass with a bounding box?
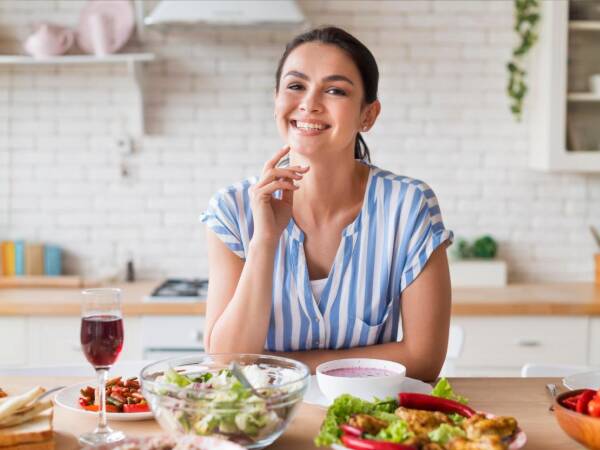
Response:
[27,316,142,366]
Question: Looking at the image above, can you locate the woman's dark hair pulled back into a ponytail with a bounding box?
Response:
[275,27,379,162]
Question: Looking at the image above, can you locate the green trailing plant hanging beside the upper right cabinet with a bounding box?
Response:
[506,0,540,121]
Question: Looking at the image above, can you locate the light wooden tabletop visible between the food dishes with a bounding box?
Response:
[0,377,583,450]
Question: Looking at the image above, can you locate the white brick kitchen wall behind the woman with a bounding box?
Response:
[0,0,600,281]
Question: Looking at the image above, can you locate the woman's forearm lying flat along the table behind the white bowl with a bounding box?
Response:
[269,342,443,381]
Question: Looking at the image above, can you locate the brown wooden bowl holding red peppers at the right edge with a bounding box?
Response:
[554,386,600,450]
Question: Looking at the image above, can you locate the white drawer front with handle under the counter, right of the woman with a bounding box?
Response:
[452,316,589,368]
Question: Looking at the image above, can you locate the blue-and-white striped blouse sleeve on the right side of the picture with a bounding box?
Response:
[400,182,454,291]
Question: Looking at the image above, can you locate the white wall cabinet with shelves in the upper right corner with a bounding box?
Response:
[526,0,600,172]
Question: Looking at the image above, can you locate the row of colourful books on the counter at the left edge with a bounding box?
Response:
[0,240,62,277]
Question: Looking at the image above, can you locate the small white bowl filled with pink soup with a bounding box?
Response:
[316,358,406,401]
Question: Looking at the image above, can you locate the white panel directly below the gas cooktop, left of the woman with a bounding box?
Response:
[142,316,204,351]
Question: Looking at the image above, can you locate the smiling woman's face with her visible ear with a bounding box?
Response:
[275,42,379,159]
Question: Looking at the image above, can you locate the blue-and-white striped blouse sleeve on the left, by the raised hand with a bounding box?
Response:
[200,190,246,259]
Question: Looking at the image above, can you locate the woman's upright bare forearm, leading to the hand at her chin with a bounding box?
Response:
[207,241,276,353]
